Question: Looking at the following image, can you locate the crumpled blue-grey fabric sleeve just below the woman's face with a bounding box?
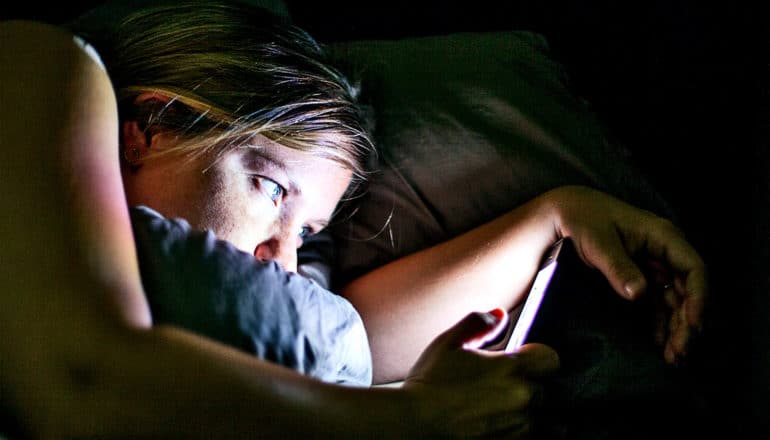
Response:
[130,207,372,386]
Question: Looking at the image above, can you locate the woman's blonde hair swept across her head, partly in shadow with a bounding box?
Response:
[74,2,374,179]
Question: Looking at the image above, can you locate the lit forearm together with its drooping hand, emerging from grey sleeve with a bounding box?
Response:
[342,186,707,383]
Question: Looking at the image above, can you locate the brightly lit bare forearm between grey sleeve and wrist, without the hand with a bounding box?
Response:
[342,192,558,383]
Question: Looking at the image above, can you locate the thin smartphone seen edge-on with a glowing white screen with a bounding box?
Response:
[485,238,568,353]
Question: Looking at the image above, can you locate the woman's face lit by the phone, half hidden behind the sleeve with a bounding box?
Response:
[124,135,352,271]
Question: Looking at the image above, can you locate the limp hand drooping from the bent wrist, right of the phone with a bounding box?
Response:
[543,186,708,363]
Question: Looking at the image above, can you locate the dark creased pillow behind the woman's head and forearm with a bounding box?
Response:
[330,31,672,285]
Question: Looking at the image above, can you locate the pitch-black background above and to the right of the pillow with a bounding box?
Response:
[6,0,770,438]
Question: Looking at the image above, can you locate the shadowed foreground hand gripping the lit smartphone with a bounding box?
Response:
[403,309,559,438]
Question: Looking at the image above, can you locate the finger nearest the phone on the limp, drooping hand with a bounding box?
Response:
[576,232,647,299]
